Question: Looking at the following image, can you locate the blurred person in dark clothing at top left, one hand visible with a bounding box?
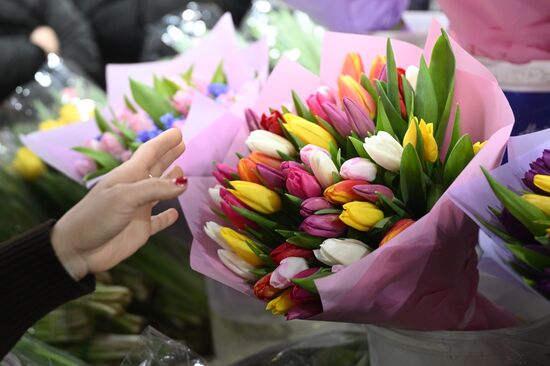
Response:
[0,0,103,101]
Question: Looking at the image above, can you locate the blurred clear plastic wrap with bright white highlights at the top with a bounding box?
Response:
[141,1,229,61]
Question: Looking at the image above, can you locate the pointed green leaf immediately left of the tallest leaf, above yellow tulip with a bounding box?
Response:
[414,56,439,126]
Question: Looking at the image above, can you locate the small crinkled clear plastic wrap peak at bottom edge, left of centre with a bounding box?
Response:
[121,327,206,366]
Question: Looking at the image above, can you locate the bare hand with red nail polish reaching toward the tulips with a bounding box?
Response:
[51,129,187,281]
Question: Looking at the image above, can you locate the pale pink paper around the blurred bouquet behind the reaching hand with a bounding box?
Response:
[21,14,269,187]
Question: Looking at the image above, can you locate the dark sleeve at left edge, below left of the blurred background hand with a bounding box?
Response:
[0,35,46,101]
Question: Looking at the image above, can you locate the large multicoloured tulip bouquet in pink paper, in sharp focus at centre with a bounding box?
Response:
[181,24,515,330]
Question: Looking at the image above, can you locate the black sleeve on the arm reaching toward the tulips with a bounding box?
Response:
[0,221,95,360]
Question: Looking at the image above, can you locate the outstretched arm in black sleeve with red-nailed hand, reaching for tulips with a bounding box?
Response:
[0,129,187,360]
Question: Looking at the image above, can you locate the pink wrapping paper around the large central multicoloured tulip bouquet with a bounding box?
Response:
[185,24,516,330]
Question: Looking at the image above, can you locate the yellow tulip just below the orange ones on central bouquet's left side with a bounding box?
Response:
[229,180,282,215]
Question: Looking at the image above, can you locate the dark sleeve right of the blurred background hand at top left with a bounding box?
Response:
[43,0,104,84]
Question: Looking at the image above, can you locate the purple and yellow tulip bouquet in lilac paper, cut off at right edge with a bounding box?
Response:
[453,130,550,299]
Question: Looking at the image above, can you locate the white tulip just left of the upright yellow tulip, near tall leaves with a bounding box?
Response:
[363,131,403,172]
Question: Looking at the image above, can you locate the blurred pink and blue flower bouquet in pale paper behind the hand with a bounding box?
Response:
[22,14,268,186]
